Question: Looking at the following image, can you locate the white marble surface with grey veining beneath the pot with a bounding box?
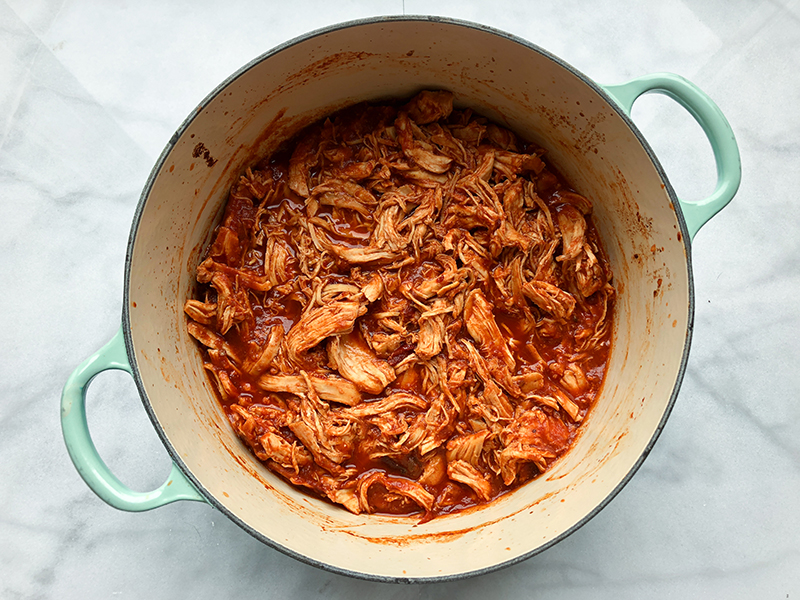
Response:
[0,0,800,600]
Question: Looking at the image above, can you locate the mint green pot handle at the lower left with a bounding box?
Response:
[61,328,205,512]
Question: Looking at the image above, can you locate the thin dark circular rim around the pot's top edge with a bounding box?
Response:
[122,15,695,583]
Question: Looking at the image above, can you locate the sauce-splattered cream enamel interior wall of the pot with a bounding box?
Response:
[127,20,691,579]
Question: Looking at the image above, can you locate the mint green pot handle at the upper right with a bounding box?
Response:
[602,73,742,239]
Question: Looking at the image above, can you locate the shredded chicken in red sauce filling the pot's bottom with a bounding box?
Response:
[184,91,615,519]
